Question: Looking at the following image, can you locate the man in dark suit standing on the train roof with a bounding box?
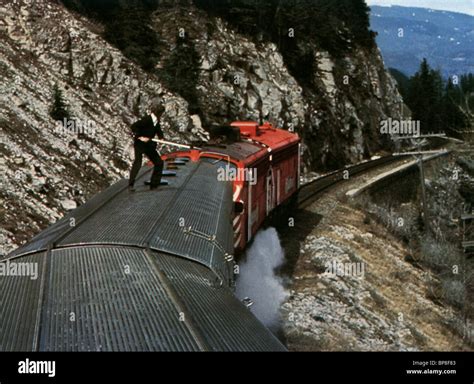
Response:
[128,99,165,192]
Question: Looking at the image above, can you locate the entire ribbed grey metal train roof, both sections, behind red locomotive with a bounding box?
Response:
[0,161,284,351]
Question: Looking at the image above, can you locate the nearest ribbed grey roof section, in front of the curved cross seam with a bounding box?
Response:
[0,246,284,351]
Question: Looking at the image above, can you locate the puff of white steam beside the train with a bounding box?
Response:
[236,228,288,330]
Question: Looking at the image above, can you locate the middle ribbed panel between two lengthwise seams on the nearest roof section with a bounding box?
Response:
[39,247,201,351]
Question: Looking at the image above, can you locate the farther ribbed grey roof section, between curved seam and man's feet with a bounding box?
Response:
[8,162,233,282]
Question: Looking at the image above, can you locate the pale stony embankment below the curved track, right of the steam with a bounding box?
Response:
[279,143,470,351]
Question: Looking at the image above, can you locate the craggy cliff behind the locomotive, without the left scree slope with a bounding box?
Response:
[150,6,403,168]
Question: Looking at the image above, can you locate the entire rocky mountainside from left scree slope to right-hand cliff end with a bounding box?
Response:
[0,0,401,252]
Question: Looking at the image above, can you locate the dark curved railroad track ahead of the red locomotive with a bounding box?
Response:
[297,155,406,208]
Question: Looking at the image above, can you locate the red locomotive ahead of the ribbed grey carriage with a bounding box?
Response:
[163,121,300,252]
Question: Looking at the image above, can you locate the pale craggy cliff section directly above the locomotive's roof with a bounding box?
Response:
[152,8,307,135]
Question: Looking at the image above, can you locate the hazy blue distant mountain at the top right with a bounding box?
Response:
[370,6,474,77]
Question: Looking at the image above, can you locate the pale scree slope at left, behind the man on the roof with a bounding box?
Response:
[0,0,206,253]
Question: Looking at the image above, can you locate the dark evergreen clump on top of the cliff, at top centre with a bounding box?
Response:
[194,0,375,55]
